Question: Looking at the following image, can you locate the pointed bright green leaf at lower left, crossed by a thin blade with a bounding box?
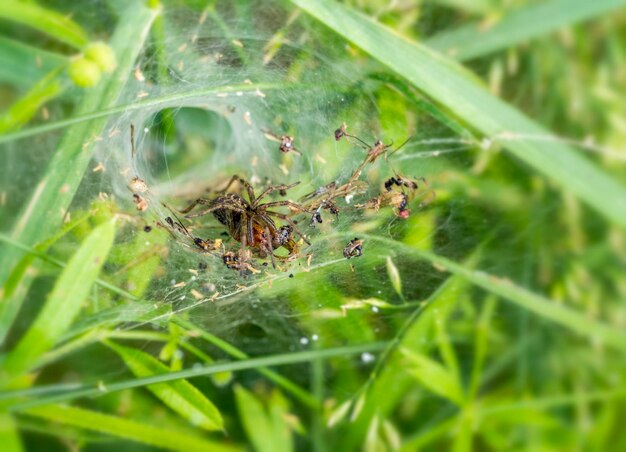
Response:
[106,342,224,430]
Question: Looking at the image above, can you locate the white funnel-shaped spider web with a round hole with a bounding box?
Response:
[2,0,624,410]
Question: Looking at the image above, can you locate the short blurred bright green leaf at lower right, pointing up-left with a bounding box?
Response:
[400,348,464,405]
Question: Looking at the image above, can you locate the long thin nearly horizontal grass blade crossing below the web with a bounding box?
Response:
[0,342,388,411]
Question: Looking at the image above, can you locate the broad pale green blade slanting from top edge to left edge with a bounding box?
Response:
[0,2,157,283]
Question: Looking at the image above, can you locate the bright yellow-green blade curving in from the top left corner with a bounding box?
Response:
[0,0,89,50]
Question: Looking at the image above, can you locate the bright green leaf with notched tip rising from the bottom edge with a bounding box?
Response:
[235,385,293,452]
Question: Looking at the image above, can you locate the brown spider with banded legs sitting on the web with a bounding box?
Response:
[180,175,310,271]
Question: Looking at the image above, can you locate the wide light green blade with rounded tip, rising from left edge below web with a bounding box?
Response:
[2,220,115,378]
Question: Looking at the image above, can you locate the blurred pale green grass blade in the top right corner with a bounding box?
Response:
[425,0,626,61]
